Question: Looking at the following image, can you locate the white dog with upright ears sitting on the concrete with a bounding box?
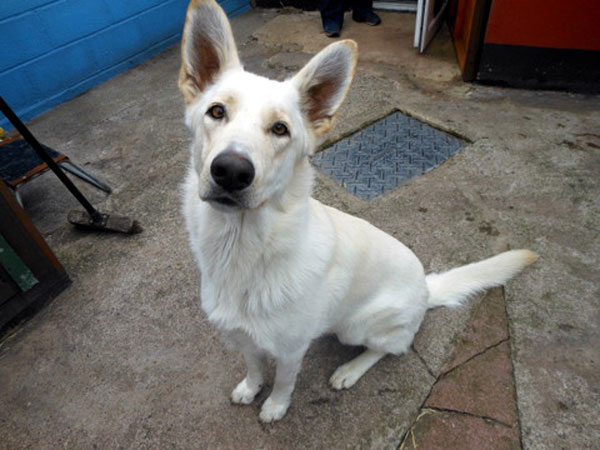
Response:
[179,0,537,422]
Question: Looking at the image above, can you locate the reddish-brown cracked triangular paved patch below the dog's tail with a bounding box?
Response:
[410,288,521,450]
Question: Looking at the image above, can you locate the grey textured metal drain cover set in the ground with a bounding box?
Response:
[313,112,464,200]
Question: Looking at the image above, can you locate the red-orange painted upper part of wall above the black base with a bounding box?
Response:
[485,0,600,50]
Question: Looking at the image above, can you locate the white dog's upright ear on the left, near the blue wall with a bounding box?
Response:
[179,0,240,104]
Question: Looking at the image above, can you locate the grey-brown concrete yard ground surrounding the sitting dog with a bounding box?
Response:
[0,10,600,449]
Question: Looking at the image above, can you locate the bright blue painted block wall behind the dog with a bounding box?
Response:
[0,0,250,129]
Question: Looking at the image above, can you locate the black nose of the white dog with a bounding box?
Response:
[210,151,254,192]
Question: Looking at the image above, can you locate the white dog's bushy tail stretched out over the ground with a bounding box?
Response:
[426,250,538,308]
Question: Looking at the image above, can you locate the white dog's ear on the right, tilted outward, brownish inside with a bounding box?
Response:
[292,40,358,135]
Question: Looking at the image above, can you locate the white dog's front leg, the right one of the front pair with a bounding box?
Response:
[259,350,306,422]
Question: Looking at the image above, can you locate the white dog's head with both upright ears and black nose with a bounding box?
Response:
[179,0,357,211]
